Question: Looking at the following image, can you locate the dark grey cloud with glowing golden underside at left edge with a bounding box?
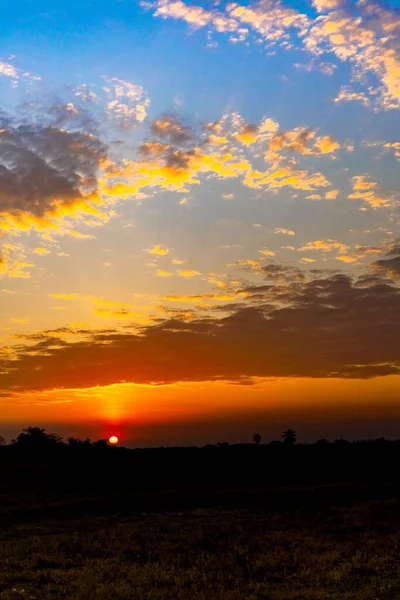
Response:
[0,114,106,230]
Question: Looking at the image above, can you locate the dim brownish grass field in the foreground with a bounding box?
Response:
[0,500,400,600]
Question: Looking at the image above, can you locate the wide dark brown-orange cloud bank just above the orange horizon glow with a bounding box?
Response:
[0,258,400,393]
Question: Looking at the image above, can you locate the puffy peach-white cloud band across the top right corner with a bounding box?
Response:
[147,0,400,110]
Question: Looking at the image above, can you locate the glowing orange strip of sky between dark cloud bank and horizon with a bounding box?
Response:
[0,376,400,444]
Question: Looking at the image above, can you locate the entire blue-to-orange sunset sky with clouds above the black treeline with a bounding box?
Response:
[0,0,400,447]
